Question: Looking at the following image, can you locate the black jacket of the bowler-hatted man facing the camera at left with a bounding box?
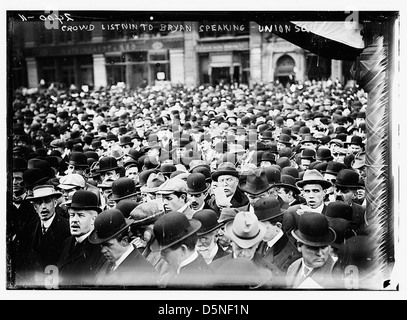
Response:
[58,236,106,288]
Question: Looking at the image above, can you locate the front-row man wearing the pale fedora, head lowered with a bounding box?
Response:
[211,211,285,288]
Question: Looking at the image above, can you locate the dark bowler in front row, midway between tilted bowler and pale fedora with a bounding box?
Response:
[151,211,202,251]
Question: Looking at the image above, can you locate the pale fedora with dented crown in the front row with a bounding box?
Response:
[225,211,267,249]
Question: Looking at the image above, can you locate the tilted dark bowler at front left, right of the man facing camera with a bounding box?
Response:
[89,209,134,244]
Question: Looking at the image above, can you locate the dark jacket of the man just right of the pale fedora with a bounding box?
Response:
[257,233,301,275]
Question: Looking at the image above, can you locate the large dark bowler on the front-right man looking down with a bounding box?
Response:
[291,212,336,247]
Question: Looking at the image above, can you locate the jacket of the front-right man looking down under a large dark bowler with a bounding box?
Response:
[286,256,335,289]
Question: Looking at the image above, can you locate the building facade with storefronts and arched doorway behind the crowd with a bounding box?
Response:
[10,21,352,89]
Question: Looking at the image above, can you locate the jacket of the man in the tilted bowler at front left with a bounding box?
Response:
[95,247,158,287]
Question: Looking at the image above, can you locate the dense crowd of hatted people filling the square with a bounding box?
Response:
[7,80,381,290]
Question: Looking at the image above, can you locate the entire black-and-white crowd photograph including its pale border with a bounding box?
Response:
[3,5,405,302]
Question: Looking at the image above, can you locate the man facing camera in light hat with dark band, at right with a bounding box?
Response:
[283,169,332,239]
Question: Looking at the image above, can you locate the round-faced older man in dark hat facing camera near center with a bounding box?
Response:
[208,162,249,217]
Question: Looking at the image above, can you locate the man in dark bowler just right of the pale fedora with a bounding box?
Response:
[253,197,301,275]
